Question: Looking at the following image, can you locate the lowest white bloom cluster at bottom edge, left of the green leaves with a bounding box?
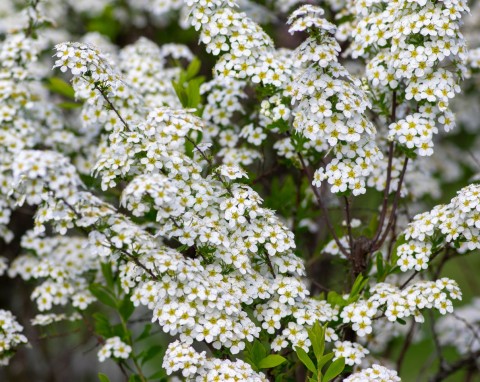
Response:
[163,341,268,382]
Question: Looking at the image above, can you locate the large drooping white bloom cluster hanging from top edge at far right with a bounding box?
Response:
[338,0,469,156]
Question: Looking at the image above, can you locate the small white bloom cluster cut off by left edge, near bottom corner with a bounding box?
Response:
[0,309,28,365]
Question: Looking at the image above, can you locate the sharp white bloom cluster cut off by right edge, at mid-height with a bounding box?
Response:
[397,184,480,272]
